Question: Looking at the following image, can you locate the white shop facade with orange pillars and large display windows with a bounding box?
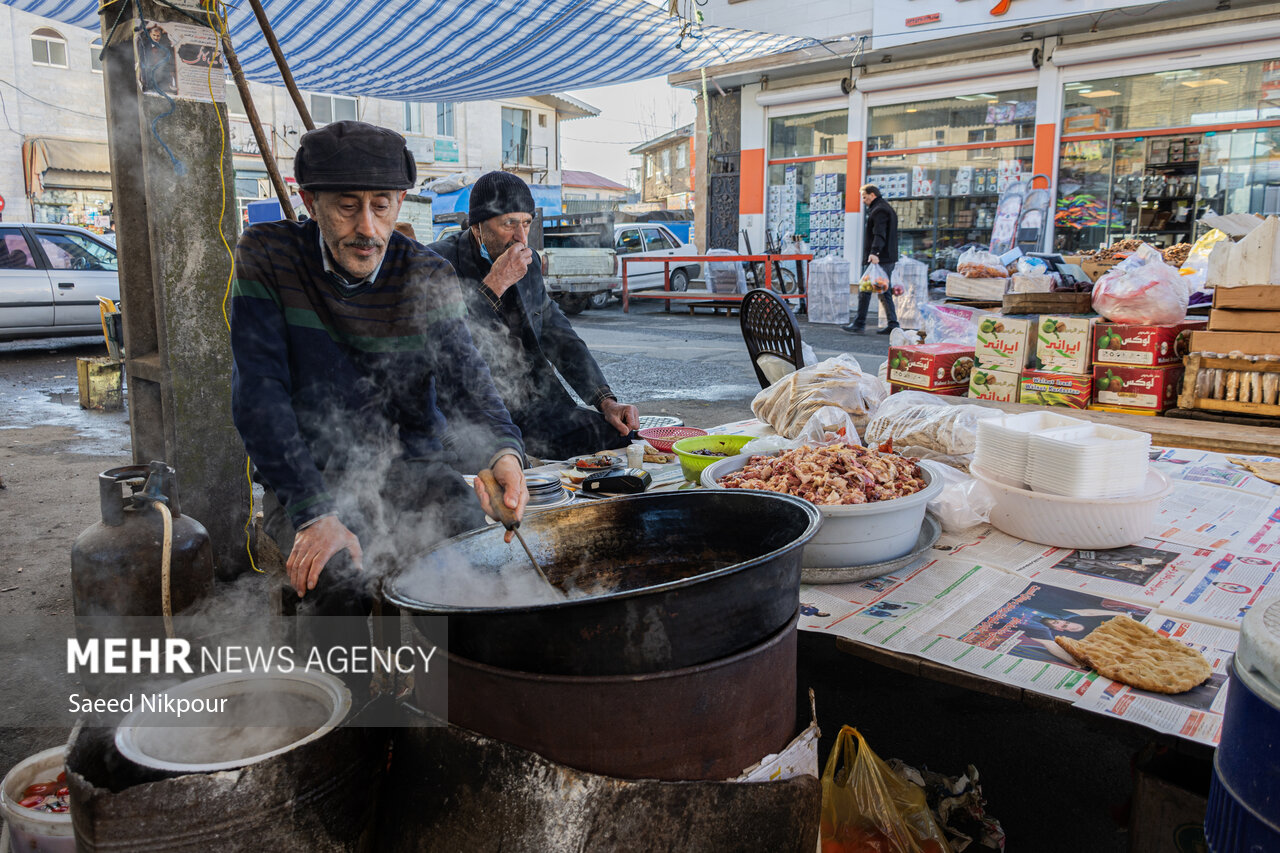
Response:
[671,0,1280,274]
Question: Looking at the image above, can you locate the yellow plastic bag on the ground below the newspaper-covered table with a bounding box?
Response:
[819,726,951,853]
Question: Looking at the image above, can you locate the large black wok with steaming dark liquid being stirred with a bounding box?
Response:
[383,491,822,675]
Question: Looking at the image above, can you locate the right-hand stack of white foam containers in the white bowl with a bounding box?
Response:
[1027,424,1151,500]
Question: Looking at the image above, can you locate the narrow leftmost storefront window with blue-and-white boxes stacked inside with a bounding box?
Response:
[751,110,849,257]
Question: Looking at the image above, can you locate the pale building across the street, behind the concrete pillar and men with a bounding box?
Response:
[0,6,599,231]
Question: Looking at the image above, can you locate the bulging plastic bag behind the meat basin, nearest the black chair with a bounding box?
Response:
[751,353,887,438]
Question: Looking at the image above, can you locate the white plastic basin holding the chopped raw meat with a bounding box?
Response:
[701,453,943,569]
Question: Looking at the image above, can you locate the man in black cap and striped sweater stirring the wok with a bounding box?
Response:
[230,122,529,630]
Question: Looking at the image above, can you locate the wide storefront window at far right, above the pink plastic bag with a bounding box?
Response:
[1055,61,1280,251]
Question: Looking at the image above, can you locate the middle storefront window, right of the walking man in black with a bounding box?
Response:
[867,88,1036,269]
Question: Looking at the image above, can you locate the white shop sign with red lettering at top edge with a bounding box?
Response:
[872,0,1151,50]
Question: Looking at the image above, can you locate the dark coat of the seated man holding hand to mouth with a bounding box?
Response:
[429,231,608,424]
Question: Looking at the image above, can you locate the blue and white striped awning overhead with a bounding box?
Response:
[0,0,814,101]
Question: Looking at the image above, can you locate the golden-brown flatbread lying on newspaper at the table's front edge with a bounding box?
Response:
[1053,616,1213,693]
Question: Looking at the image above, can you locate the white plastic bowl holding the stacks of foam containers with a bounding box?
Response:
[969,465,1174,549]
